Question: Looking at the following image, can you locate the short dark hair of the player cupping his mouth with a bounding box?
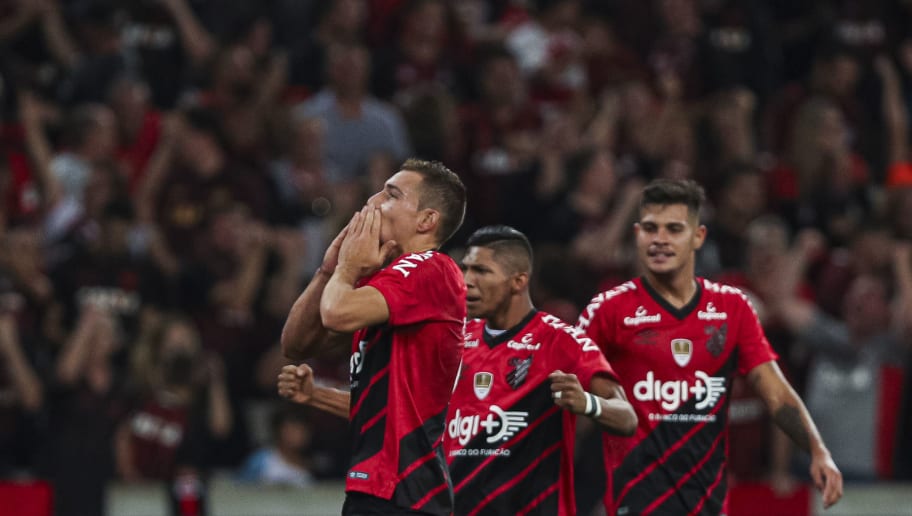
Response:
[399,158,466,245]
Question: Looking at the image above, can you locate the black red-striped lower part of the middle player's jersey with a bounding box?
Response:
[450,382,563,514]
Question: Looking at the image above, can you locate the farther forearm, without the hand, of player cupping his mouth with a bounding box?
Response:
[281,269,330,360]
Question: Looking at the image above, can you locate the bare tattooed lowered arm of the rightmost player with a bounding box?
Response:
[747,361,842,507]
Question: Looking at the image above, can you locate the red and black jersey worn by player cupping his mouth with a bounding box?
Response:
[345,251,466,514]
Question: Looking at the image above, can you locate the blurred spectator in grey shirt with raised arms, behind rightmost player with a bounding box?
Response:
[775,275,904,481]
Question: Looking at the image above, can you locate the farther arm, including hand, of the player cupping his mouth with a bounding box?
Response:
[281,226,348,360]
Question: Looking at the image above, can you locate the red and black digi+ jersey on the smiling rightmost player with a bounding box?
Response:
[577,278,777,515]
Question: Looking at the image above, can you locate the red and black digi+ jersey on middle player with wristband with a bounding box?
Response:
[445,310,615,516]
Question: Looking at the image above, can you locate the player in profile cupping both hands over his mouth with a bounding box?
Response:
[282,159,466,515]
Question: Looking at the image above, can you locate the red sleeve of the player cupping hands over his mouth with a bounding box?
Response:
[367,256,465,326]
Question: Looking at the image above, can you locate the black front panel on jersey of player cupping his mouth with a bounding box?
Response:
[350,332,392,466]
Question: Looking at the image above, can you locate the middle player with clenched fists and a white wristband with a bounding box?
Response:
[279,226,636,515]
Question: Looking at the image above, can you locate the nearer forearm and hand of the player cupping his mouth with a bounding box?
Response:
[320,206,396,333]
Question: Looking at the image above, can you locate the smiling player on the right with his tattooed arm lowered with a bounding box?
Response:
[577,179,842,515]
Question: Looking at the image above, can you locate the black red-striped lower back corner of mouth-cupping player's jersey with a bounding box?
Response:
[393,409,453,514]
